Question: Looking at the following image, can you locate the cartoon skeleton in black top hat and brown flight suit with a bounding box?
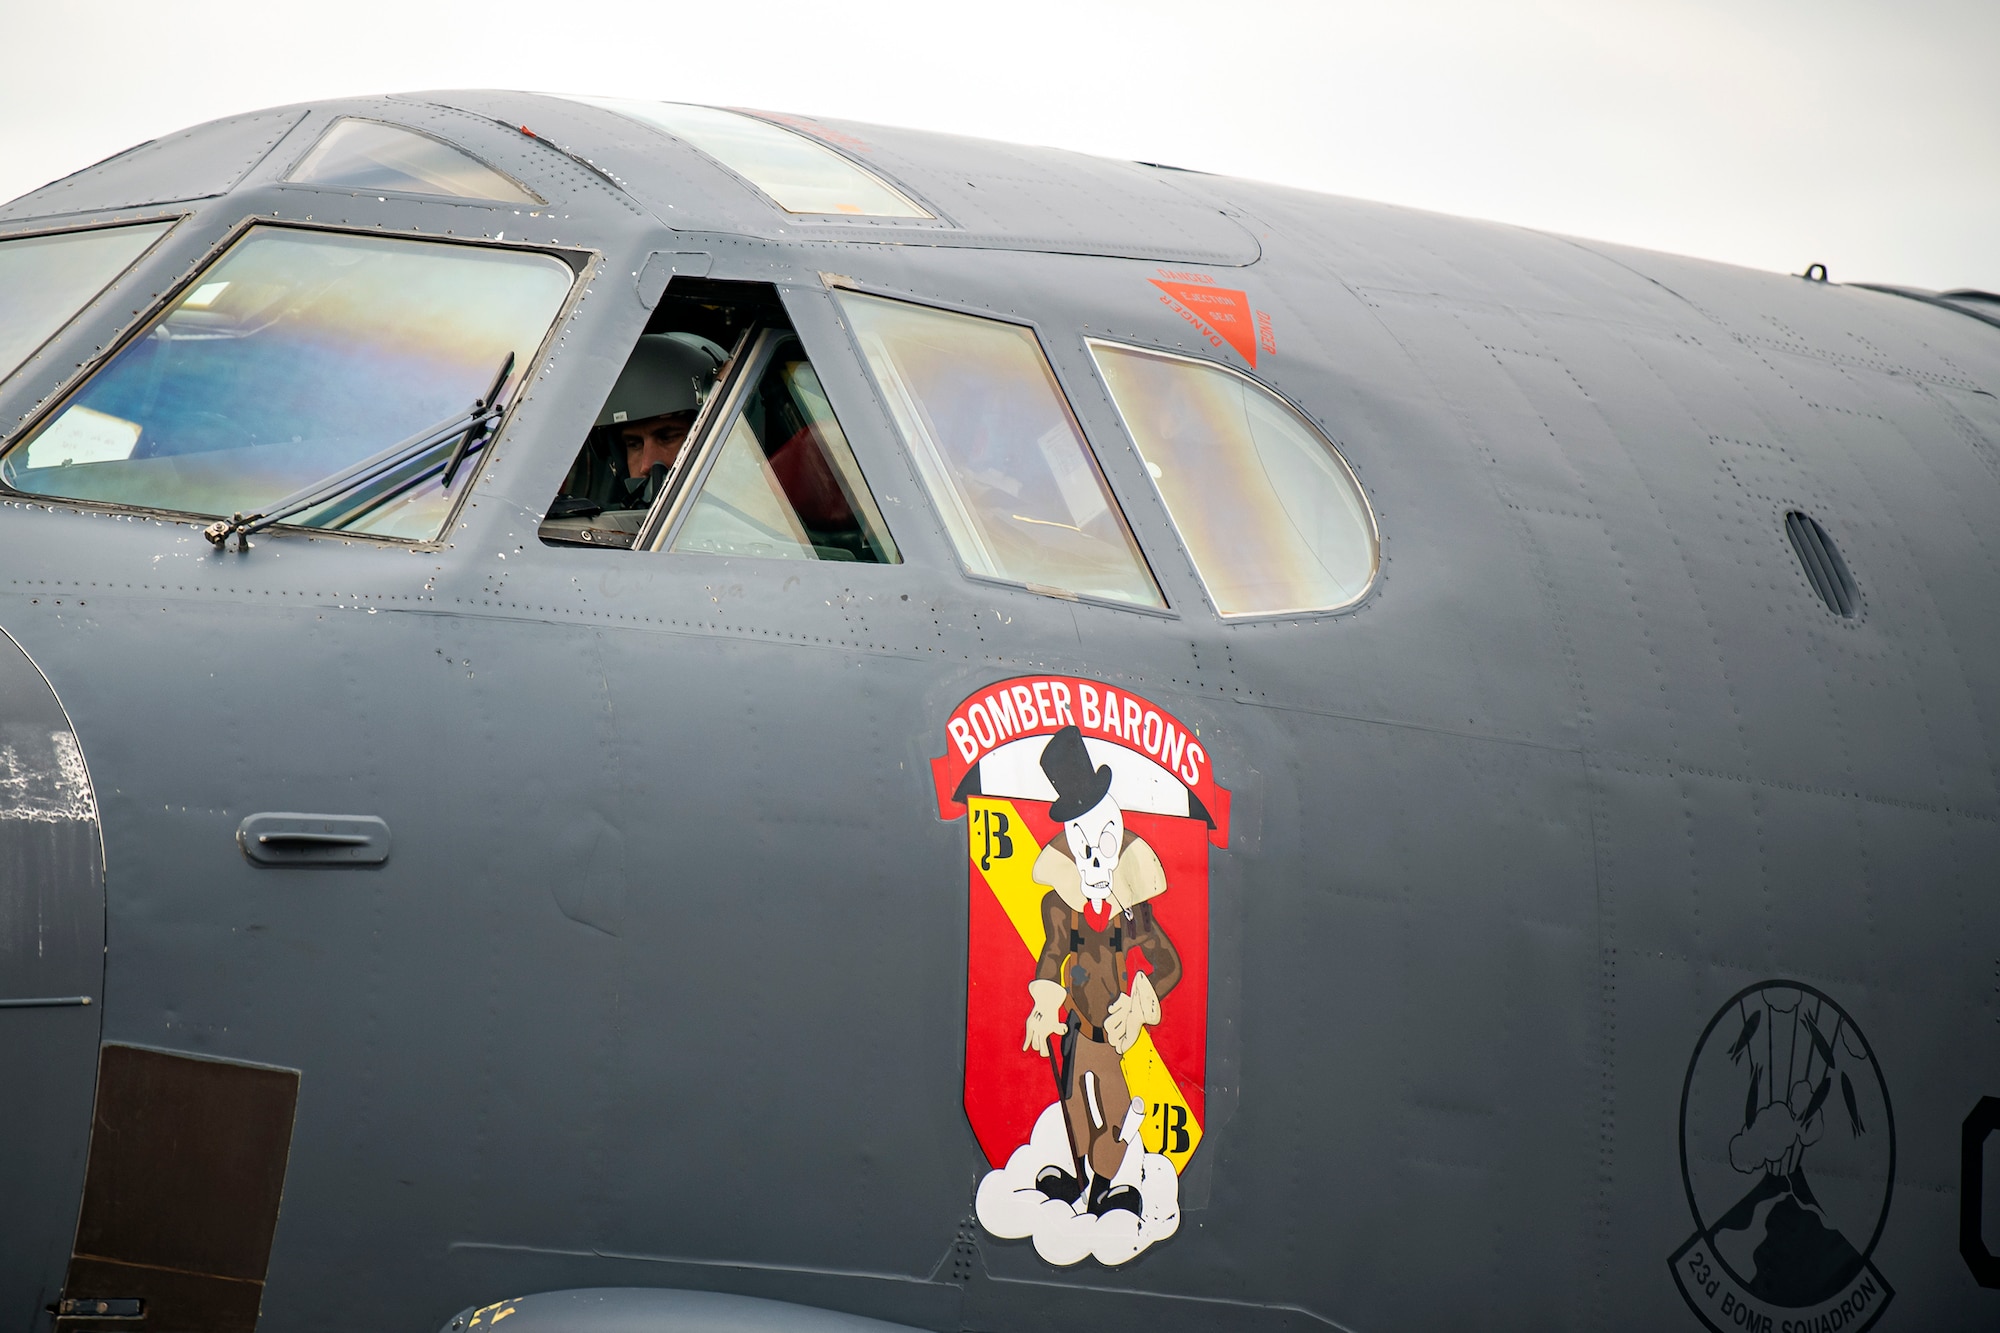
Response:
[1022,727,1180,1217]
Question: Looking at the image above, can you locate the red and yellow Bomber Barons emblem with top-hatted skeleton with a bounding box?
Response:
[932,677,1230,1265]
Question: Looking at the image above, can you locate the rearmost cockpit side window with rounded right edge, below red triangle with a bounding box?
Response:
[1090,340,1380,616]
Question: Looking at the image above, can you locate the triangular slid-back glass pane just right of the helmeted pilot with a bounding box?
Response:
[668,330,898,564]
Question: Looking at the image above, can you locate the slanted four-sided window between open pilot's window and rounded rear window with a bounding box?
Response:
[840,292,1166,606]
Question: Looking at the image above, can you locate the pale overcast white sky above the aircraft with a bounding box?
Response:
[0,0,2000,290]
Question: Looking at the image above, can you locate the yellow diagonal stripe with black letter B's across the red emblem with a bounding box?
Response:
[966,797,1202,1171]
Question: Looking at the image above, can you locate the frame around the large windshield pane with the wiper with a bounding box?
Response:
[0,217,604,550]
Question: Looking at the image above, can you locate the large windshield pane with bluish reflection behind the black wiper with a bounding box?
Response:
[0,226,574,540]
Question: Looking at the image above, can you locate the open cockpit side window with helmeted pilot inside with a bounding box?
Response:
[542,278,900,564]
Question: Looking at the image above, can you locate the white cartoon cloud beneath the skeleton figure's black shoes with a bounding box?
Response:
[974,1103,1180,1267]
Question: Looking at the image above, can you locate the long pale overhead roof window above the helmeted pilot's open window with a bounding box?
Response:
[572,98,932,218]
